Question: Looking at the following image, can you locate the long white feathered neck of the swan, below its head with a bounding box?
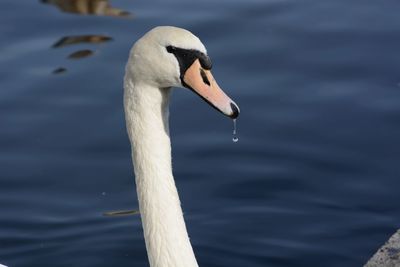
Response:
[124,79,198,267]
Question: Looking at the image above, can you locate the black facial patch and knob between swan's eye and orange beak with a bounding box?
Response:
[166,45,212,87]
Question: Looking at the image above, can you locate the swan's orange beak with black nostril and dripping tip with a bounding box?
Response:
[183,59,240,119]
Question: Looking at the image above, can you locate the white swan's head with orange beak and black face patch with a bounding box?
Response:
[127,26,240,118]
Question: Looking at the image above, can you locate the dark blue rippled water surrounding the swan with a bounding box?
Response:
[0,0,400,267]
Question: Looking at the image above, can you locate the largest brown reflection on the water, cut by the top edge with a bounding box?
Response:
[41,0,130,17]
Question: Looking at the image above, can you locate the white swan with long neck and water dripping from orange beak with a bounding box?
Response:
[124,26,239,267]
